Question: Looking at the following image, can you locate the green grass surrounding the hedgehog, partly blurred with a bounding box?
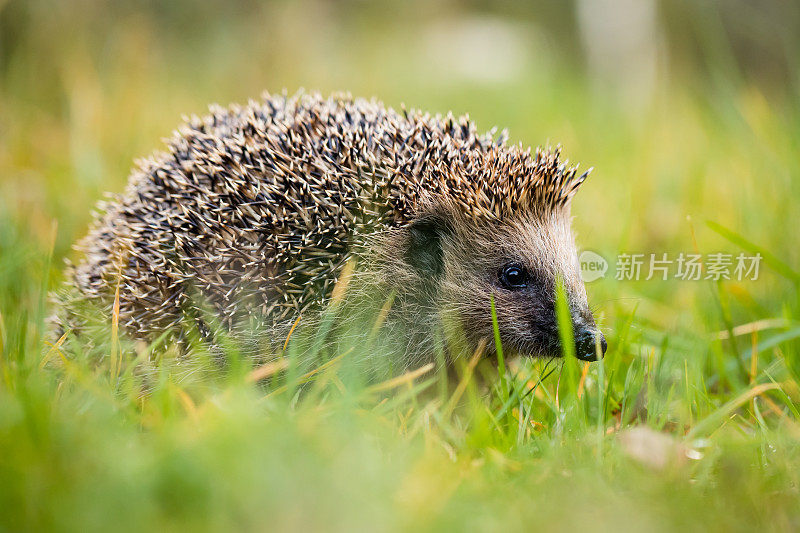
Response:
[0,2,800,531]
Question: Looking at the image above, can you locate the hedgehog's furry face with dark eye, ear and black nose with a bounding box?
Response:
[411,209,606,360]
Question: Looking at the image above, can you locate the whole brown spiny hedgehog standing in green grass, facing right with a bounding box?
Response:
[56,93,606,366]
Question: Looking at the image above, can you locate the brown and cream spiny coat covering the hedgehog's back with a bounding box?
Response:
[54,94,600,366]
